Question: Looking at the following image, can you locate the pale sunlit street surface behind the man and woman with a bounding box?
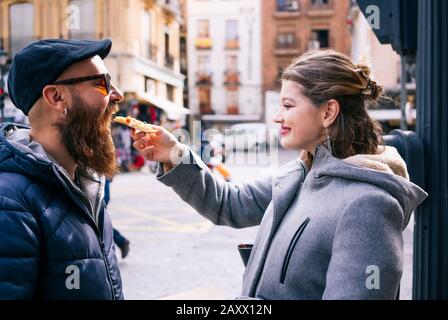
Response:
[109,150,412,299]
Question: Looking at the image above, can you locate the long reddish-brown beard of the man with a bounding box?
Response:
[58,91,118,178]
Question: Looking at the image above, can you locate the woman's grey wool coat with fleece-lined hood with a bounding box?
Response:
[157,146,427,300]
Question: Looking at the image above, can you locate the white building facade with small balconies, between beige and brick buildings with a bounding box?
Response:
[187,0,262,129]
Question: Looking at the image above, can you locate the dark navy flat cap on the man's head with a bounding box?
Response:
[8,39,112,115]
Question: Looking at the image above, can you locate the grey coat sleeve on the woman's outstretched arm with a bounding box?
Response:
[157,148,272,228]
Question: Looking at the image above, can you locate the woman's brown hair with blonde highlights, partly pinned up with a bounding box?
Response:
[282,50,383,163]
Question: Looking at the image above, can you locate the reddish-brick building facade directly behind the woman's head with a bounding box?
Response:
[261,0,351,130]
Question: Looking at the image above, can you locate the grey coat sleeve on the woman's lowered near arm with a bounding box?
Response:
[322,192,403,300]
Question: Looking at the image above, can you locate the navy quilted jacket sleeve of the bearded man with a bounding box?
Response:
[0,195,40,300]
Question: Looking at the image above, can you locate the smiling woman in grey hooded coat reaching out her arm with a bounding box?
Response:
[133,51,427,299]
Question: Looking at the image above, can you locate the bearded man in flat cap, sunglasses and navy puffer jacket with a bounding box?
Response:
[0,39,123,300]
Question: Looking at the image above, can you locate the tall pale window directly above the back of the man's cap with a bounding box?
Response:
[9,2,34,55]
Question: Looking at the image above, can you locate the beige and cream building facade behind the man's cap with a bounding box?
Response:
[0,0,189,121]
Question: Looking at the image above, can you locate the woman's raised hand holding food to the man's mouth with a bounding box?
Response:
[132,125,185,167]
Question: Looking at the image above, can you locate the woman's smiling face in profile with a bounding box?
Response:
[274,80,325,154]
